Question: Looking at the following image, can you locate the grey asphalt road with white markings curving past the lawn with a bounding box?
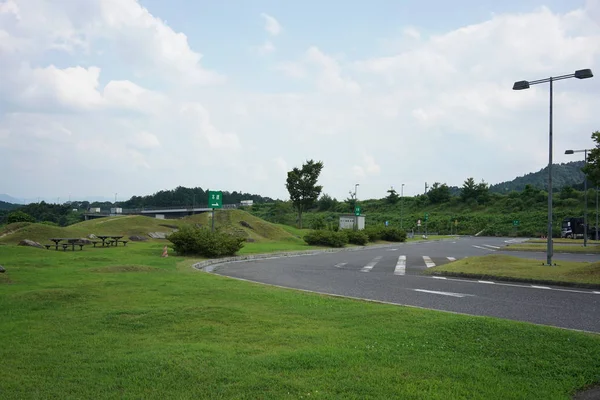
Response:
[213,237,600,333]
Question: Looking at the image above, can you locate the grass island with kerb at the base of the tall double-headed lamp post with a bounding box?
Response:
[425,254,600,285]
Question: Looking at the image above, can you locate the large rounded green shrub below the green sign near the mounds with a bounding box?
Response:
[168,226,245,257]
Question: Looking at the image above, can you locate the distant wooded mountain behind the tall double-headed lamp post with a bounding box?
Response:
[490,161,585,193]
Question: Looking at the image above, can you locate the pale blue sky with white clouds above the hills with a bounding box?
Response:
[0,0,600,203]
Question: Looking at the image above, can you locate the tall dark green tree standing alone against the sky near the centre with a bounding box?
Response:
[285,160,323,228]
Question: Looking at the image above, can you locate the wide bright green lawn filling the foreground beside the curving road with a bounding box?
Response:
[0,242,600,399]
